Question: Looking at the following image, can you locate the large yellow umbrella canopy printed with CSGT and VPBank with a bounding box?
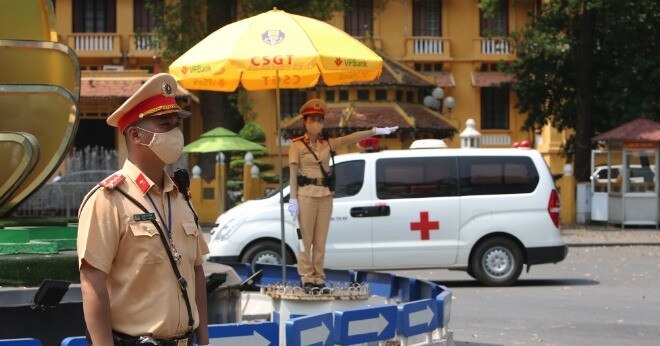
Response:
[170,10,383,91]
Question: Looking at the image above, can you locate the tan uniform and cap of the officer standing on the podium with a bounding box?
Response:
[289,99,373,285]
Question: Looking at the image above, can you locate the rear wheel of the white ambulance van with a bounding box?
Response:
[470,238,523,286]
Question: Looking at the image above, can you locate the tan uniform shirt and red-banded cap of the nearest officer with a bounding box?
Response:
[77,73,209,339]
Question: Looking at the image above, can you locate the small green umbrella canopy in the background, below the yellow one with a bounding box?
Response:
[183,127,266,153]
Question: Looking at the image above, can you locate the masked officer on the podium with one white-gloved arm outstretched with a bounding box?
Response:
[289,99,398,293]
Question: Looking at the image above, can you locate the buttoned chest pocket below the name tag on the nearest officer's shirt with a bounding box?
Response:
[128,222,165,263]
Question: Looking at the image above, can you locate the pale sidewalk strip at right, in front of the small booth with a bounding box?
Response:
[561,224,660,247]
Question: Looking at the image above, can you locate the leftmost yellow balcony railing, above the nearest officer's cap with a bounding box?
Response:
[67,33,122,58]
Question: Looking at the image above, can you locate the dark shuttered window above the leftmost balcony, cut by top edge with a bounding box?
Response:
[72,0,117,32]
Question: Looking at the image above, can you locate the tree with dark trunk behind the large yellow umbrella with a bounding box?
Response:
[147,0,346,179]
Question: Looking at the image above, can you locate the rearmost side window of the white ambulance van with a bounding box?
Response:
[458,156,539,196]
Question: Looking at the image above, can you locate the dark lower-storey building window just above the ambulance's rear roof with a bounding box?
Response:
[481,88,509,130]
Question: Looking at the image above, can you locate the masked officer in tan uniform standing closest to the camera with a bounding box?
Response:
[78,73,209,346]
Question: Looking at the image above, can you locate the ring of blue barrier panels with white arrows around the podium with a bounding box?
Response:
[5,263,452,346]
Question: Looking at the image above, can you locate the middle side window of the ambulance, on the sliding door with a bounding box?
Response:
[376,157,458,199]
